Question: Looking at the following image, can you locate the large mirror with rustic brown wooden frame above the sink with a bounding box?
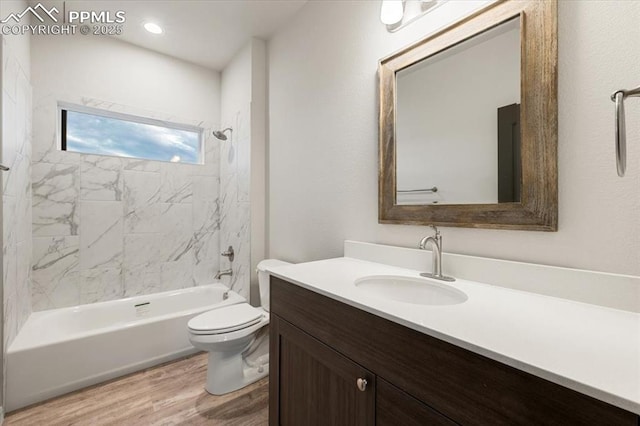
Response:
[378,0,558,231]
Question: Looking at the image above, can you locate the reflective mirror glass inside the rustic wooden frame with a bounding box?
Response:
[396,18,521,205]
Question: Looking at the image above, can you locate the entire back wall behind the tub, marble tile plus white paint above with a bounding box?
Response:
[31,36,225,310]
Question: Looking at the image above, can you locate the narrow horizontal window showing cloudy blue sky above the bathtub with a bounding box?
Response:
[60,105,203,164]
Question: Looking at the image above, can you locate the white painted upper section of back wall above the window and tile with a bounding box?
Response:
[32,36,220,122]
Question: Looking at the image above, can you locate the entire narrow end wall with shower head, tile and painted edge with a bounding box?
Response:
[219,38,266,305]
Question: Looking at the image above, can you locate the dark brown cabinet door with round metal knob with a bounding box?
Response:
[269,315,376,426]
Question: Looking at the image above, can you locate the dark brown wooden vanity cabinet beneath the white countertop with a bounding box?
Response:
[269,277,640,426]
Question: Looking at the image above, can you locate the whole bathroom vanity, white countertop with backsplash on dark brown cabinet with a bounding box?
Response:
[270,242,640,426]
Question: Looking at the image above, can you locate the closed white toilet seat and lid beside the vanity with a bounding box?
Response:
[187,303,265,335]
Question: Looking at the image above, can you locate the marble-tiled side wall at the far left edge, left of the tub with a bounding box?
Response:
[1,37,32,350]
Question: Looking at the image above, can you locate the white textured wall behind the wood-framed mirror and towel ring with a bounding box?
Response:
[268,1,640,274]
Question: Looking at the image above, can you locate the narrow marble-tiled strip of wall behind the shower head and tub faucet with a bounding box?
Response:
[220,103,255,298]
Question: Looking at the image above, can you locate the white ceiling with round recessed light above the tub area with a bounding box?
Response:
[29,0,307,71]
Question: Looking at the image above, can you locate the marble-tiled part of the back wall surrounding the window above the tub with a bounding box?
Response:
[32,94,228,311]
